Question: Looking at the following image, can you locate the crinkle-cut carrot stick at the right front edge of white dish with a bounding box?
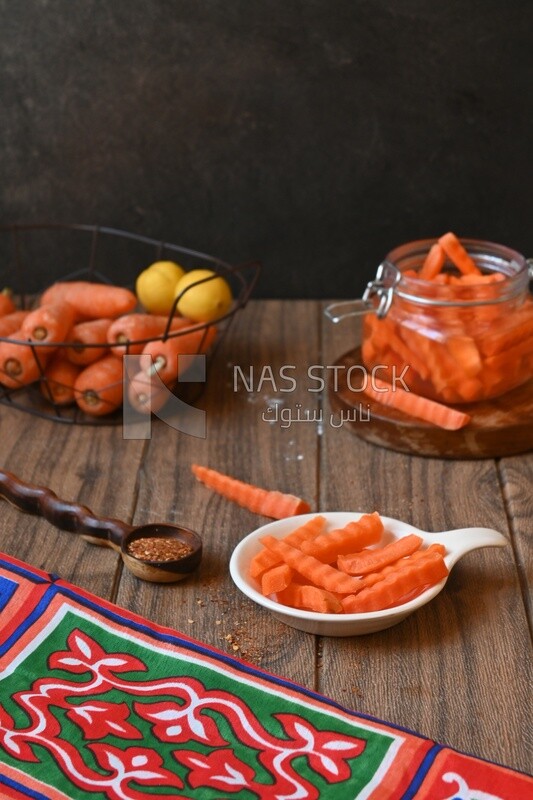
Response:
[341,551,448,614]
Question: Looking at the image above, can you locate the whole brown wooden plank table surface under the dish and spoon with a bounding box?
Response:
[0,300,533,772]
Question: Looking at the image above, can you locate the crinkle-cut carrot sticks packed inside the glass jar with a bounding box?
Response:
[363,233,533,406]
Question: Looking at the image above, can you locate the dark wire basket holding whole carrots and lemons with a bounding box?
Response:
[0,224,260,425]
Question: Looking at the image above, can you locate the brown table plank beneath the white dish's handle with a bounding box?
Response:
[318,298,533,770]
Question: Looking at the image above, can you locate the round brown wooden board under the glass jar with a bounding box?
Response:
[328,347,533,459]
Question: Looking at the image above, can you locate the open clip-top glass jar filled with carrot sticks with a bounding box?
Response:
[327,239,533,403]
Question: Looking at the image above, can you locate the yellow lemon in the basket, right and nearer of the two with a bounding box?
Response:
[175,269,233,322]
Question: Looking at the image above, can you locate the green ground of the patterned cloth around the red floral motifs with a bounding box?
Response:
[0,611,393,800]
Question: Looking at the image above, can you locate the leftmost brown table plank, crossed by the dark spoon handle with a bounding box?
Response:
[0,406,144,599]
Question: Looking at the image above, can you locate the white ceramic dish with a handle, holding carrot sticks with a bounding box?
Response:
[230,511,508,636]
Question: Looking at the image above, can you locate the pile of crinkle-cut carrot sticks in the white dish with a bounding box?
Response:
[249,512,448,614]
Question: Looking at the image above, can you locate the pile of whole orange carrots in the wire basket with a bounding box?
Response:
[0,281,216,416]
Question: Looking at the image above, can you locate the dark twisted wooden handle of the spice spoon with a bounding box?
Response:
[0,470,133,549]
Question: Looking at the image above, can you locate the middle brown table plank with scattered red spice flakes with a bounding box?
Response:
[118,301,318,687]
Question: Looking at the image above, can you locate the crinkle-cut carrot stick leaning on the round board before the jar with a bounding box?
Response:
[365,378,470,431]
